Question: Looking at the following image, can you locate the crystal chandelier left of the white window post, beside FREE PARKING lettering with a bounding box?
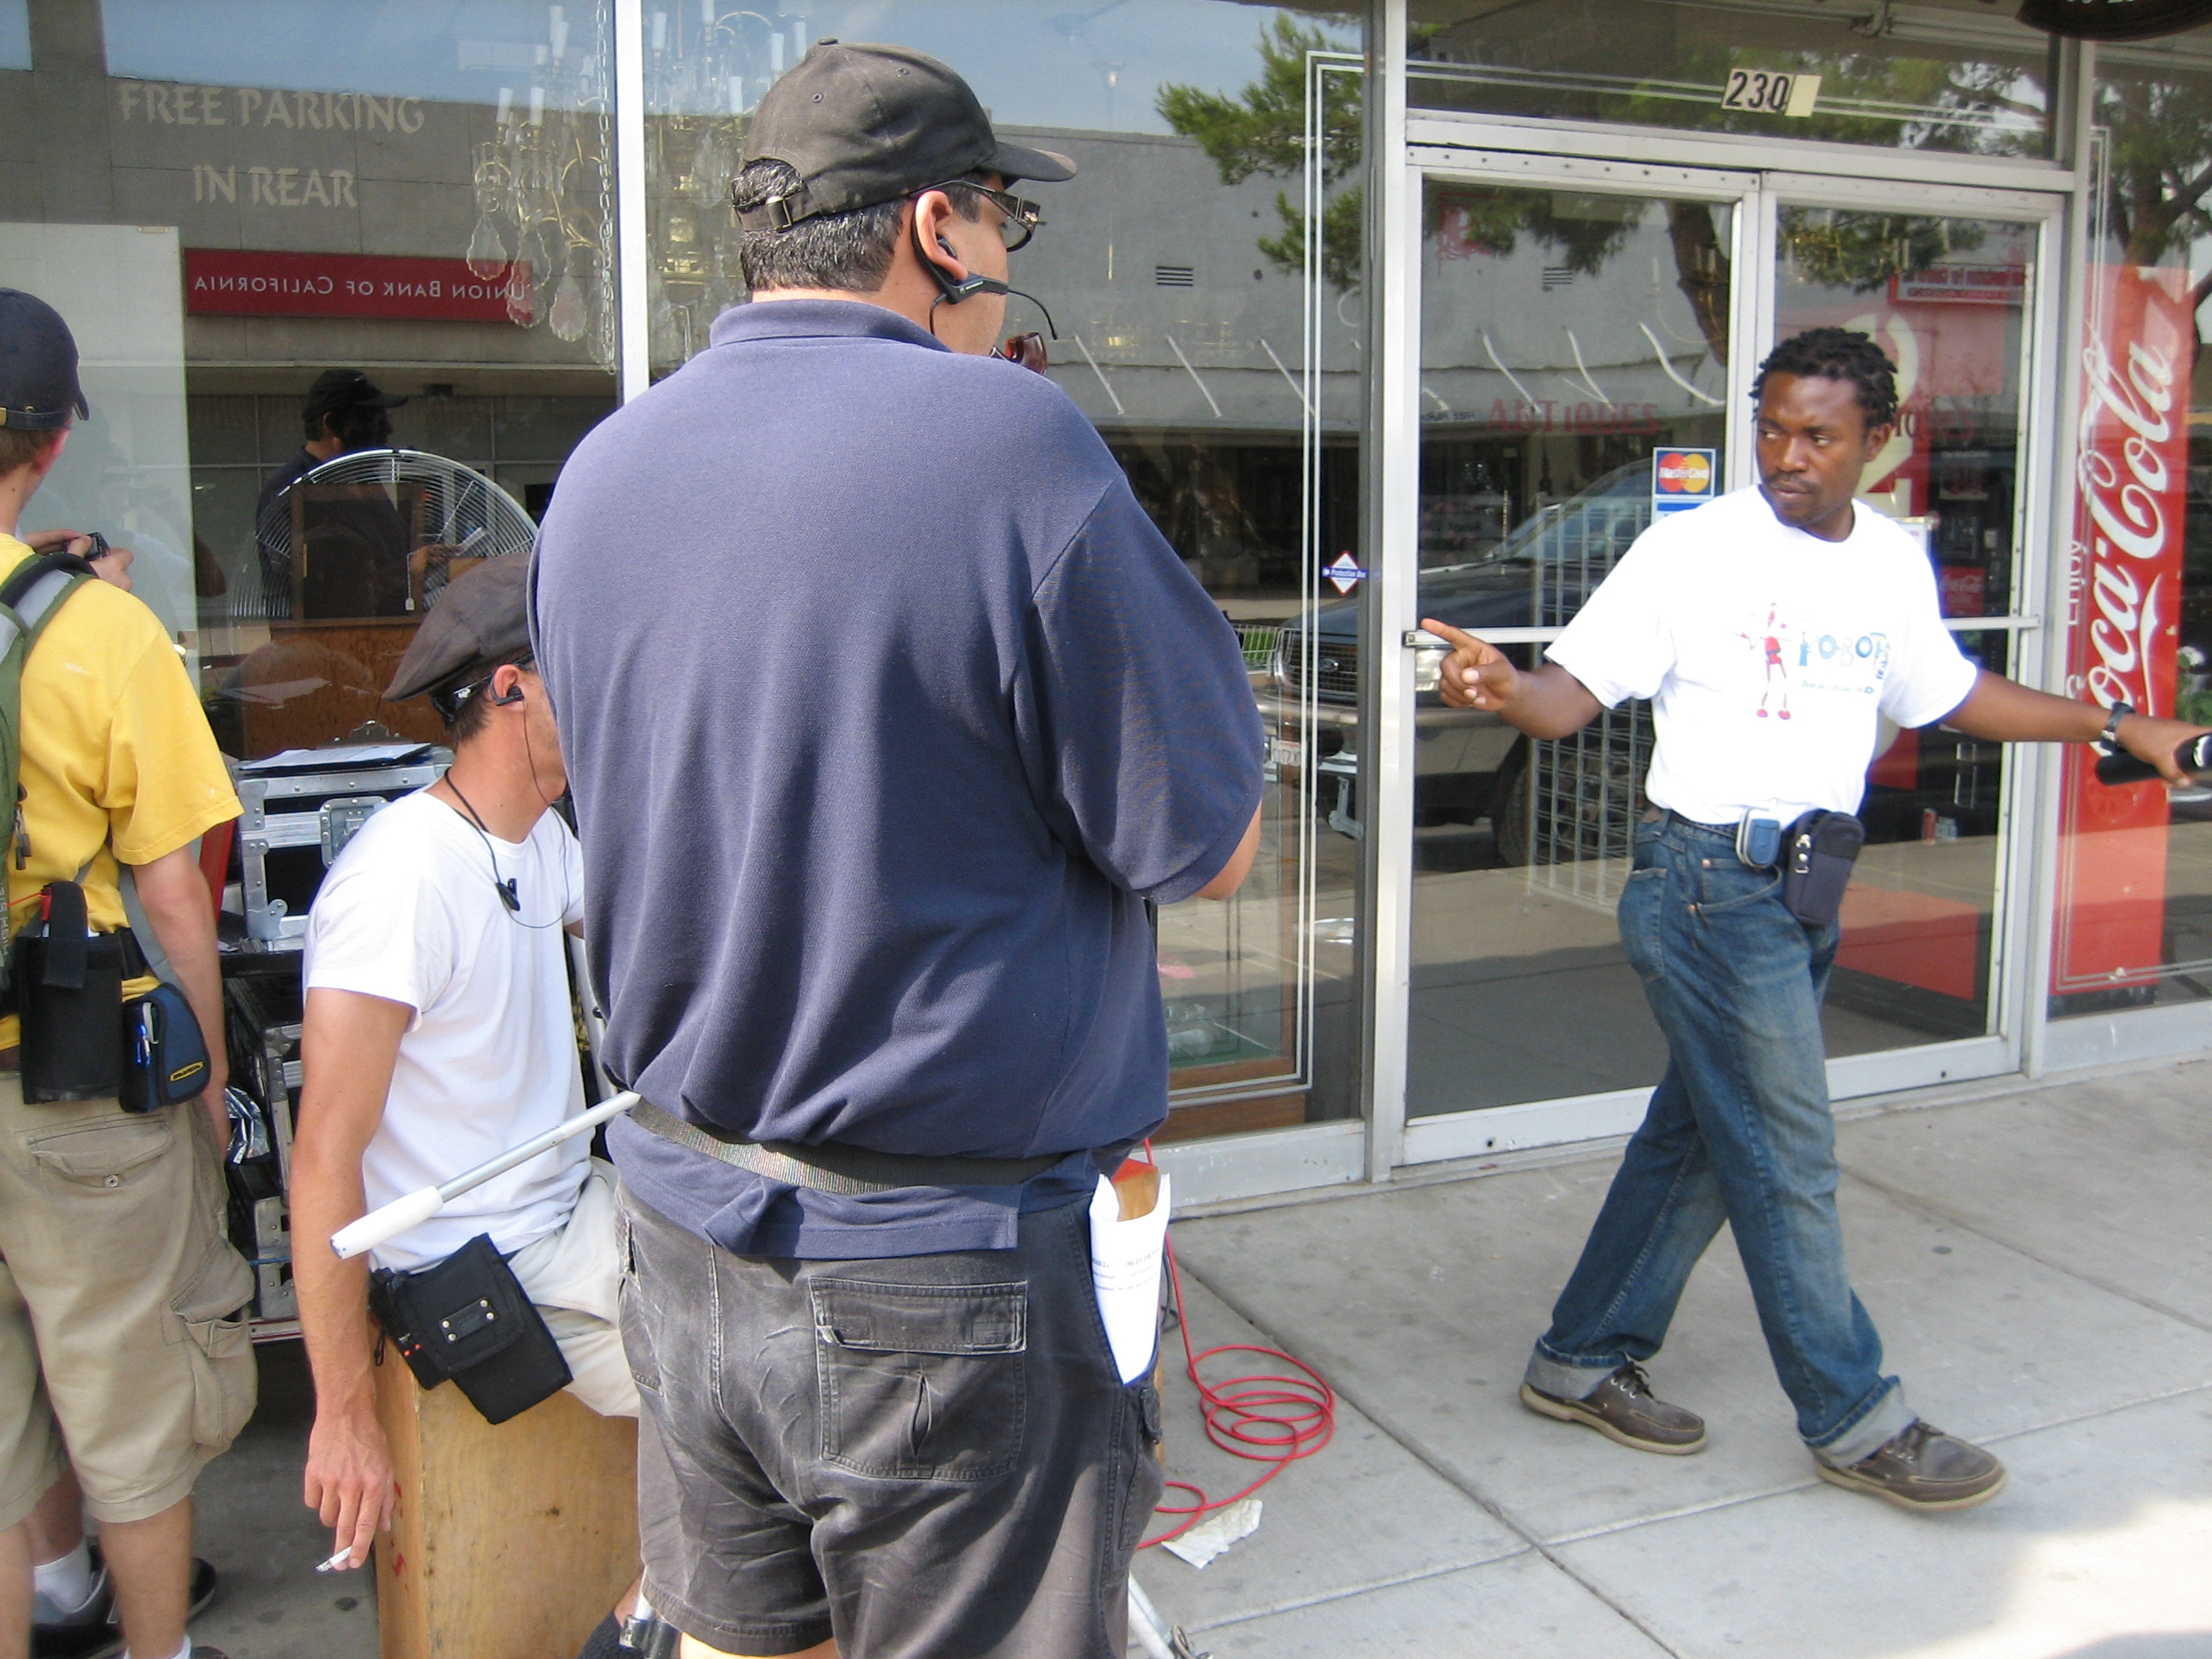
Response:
[467,4,617,370]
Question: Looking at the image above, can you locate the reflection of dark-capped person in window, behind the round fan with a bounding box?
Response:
[254,370,407,621]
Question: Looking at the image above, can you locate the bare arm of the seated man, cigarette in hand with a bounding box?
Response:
[292,989,414,1566]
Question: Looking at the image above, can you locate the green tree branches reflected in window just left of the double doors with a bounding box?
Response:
[1159,15,1363,290]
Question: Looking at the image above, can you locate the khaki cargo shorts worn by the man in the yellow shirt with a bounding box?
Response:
[0,1071,254,1528]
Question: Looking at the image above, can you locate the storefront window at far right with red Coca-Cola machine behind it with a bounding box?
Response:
[2051,31,2212,1016]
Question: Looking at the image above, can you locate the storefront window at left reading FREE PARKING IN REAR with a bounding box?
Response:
[0,0,615,759]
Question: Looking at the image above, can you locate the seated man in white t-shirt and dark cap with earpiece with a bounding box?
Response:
[292,557,637,1652]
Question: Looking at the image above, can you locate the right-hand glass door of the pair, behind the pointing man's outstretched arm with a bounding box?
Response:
[1770,179,2044,1092]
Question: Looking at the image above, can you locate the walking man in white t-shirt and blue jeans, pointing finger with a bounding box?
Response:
[1423,328,2198,1511]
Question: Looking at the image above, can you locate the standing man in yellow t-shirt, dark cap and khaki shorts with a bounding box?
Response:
[0,290,254,1659]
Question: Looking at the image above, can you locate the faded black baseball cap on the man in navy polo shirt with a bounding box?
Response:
[736,40,1075,230]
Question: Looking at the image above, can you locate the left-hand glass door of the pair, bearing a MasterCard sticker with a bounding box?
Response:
[1407,166,1756,1159]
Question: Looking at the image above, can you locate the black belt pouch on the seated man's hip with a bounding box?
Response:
[370,1232,571,1423]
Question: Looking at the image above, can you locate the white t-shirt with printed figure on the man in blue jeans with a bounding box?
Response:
[1546,486,1976,825]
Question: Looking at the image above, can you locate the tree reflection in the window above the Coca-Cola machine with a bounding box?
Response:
[2097,78,2212,327]
